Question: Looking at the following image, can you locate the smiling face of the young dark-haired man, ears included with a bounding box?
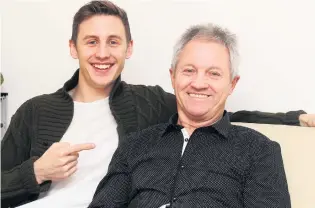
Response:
[70,15,132,91]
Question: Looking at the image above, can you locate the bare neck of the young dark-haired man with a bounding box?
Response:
[72,78,113,103]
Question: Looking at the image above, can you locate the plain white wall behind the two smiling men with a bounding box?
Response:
[0,0,315,125]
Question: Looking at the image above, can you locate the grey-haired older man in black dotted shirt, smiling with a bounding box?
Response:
[89,24,290,208]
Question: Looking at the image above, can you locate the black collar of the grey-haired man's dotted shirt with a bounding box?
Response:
[162,111,232,138]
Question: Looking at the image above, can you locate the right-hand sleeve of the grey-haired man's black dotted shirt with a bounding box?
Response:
[243,141,291,208]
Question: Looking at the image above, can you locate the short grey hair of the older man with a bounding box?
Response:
[171,23,239,79]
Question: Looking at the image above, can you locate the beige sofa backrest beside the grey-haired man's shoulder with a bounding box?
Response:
[234,123,315,208]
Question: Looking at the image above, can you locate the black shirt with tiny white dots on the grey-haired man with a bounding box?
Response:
[89,112,291,208]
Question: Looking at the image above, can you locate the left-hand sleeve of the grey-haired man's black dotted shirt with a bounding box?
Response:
[88,138,131,208]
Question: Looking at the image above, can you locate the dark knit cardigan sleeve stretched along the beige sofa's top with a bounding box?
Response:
[229,110,306,126]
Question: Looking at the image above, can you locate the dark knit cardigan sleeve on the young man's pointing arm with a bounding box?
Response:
[1,102,40,207]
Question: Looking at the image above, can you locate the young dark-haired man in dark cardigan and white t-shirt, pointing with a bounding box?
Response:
[1,1,309,207]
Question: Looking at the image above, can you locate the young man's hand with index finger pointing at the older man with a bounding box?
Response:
[34,142,95,184]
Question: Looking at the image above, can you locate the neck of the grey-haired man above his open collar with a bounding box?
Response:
[178,110,224,135]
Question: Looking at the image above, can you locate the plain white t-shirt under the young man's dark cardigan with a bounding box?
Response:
[21,98,118,208]
